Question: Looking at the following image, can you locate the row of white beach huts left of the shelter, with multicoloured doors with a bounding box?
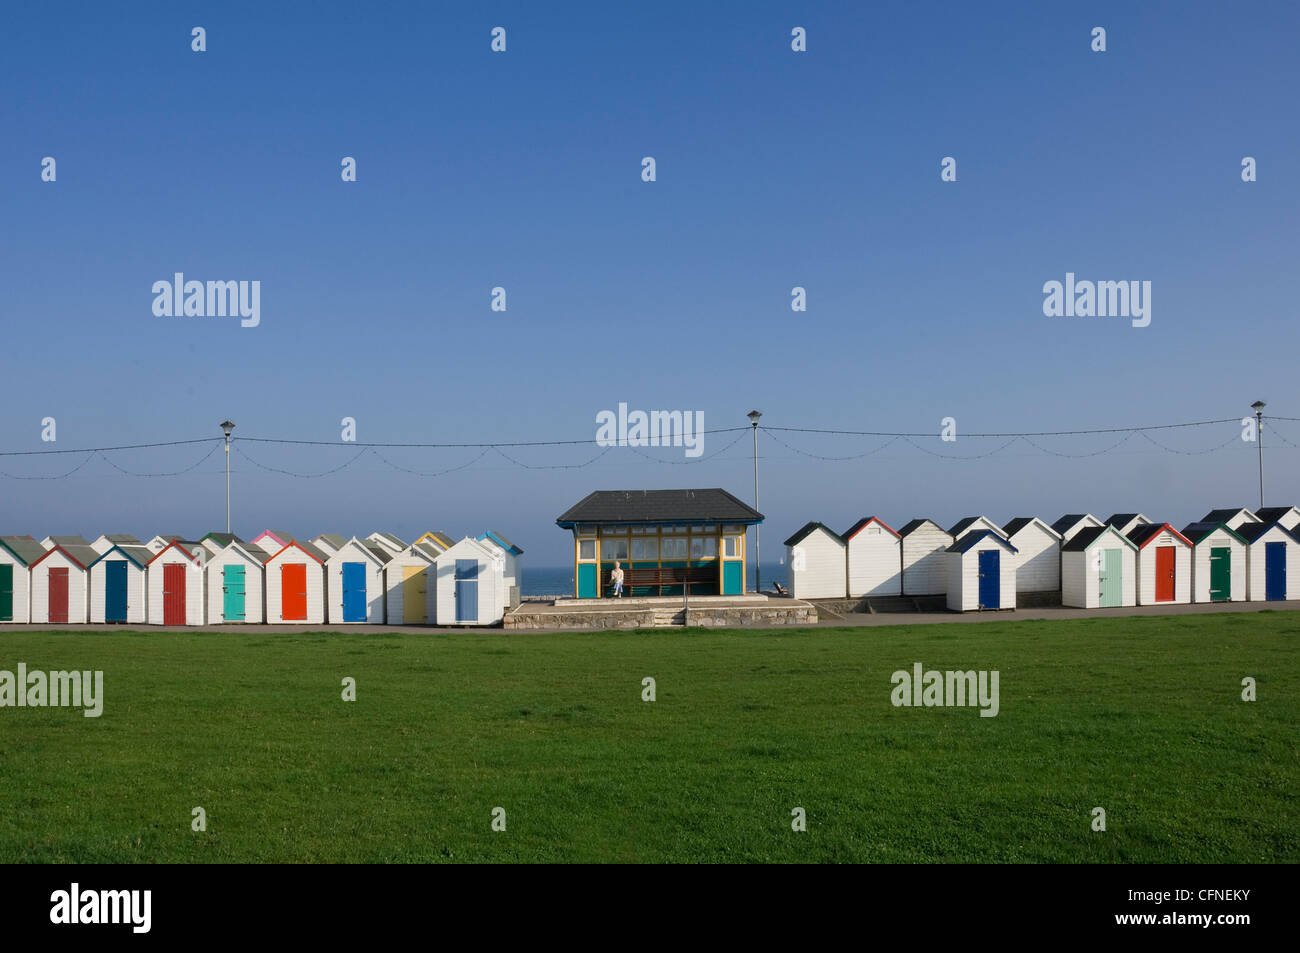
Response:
[0,529,523,625]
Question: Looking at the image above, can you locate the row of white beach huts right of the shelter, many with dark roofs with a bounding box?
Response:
[785,506,1300,611]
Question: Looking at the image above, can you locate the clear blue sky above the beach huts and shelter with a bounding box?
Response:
[0,3,1300,566]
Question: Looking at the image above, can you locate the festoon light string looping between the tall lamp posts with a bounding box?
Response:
[0,415,1300,480]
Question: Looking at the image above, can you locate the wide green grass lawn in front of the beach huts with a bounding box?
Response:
[0,612,1300,863]
